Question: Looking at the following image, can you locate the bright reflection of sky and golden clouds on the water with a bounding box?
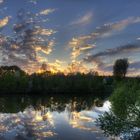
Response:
[0,98,110,140]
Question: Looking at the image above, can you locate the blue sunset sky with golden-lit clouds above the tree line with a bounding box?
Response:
[0,0,140,75]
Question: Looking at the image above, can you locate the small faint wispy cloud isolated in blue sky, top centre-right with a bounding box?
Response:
[70,12,93,25]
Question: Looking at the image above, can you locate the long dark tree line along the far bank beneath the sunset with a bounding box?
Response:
[0,66,112,98]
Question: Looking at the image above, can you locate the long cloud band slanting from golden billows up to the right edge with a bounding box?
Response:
[69,17,140,62]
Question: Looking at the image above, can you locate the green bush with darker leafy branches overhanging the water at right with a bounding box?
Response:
[97,78,140,140]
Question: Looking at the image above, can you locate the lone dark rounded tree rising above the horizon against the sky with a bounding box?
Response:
[113,58,129,77]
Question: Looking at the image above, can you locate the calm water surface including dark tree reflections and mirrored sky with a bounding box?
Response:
[0,96,109,140]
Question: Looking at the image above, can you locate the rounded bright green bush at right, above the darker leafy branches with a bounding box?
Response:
[110,79,140,121]
